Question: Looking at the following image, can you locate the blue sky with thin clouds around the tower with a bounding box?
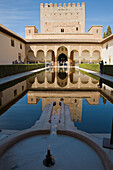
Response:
[0,0,113,38]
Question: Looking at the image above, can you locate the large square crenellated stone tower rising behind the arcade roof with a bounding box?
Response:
[40,2,85,34]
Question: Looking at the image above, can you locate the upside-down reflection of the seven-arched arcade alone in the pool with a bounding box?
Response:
[29,68,98,89]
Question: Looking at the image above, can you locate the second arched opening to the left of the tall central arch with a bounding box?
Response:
[36,50,45,63]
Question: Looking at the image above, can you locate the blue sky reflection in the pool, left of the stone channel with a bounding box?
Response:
[0,95,42,130]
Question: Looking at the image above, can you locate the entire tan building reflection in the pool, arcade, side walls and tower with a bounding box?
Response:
[0,68,113,122]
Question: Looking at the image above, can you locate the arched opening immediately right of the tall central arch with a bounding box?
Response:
[70,50,79,66]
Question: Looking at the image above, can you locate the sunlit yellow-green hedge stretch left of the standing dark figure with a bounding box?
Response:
[79,64,100,72]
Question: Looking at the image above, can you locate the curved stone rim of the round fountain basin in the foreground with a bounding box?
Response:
[0,128,113,170]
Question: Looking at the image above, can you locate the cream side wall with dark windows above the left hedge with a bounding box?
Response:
[0,24,25,65]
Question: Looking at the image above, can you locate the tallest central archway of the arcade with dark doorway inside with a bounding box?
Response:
[57,46,68,66]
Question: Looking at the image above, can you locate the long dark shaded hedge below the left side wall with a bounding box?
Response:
[0,63,45,78]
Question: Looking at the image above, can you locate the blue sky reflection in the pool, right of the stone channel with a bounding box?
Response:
[74,97,113,133]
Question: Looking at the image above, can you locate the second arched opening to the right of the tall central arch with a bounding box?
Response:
[81,50,90,63]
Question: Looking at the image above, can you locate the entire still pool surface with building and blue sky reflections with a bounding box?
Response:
[0,68,113,133]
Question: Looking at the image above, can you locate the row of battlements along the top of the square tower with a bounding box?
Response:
[40,2,85,8]
